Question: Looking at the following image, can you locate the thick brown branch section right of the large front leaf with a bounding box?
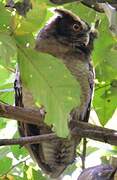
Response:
[71,122,117,146]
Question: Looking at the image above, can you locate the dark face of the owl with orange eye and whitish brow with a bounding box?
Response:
[54,9,90,45]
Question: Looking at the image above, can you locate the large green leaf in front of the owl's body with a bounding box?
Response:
[18,49,80,137]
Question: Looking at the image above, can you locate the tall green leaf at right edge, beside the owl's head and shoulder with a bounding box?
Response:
[93,16,117,81]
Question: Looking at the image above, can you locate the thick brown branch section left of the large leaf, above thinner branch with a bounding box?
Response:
[0,103,45,126]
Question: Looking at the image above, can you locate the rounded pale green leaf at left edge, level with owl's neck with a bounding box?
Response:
[0,32,17,66]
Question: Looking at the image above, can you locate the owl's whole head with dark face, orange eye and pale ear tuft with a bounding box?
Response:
[36,9,96,53]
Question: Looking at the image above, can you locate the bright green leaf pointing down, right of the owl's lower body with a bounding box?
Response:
[93,83,117,125]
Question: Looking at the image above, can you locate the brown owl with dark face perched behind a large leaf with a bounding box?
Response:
[14,9,96,178]
